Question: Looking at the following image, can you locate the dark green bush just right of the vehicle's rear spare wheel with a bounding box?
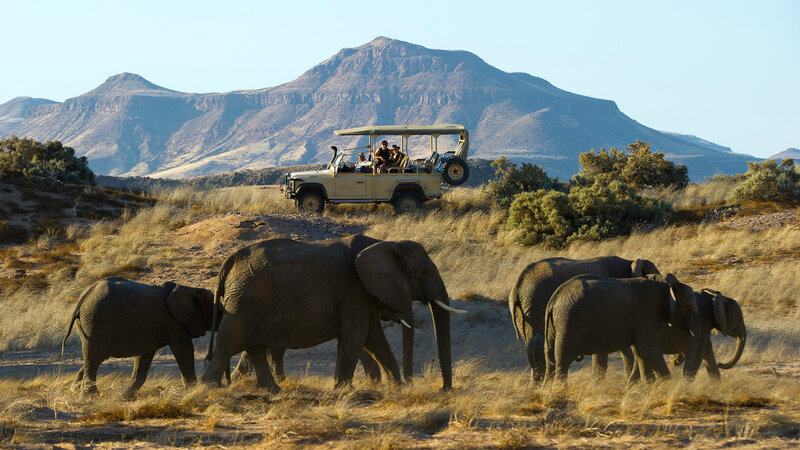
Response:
[488,156,559,208]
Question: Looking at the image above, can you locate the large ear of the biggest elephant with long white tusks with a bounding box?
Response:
[355,242,411,312]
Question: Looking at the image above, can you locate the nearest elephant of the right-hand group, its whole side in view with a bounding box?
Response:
[544,274,700,382]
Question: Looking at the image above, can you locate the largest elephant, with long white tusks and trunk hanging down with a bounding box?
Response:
[203,235,462,391]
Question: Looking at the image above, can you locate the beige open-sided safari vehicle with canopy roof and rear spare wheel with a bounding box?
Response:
[281,125,469,213]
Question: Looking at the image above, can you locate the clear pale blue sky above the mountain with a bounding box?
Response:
[0,0,800,156]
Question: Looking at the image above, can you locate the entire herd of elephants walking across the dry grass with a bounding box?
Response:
[62,235,746,397]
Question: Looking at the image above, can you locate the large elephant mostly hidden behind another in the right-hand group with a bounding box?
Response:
[508,256,659,382]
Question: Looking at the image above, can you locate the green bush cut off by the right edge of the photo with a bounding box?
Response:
[728,159,800,204]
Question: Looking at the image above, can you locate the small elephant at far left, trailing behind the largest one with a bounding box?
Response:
[61,278,214,397]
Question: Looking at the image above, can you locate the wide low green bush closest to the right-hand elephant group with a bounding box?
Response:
[507,178,671,248]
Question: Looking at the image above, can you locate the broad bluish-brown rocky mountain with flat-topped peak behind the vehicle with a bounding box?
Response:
[4,37,755,179]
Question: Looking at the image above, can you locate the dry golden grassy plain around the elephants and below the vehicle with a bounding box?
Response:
[0,183,800,448]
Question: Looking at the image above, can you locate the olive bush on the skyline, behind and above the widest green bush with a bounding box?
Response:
[573,141,689,189]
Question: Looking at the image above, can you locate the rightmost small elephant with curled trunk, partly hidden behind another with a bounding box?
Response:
[593,284,747,380]
